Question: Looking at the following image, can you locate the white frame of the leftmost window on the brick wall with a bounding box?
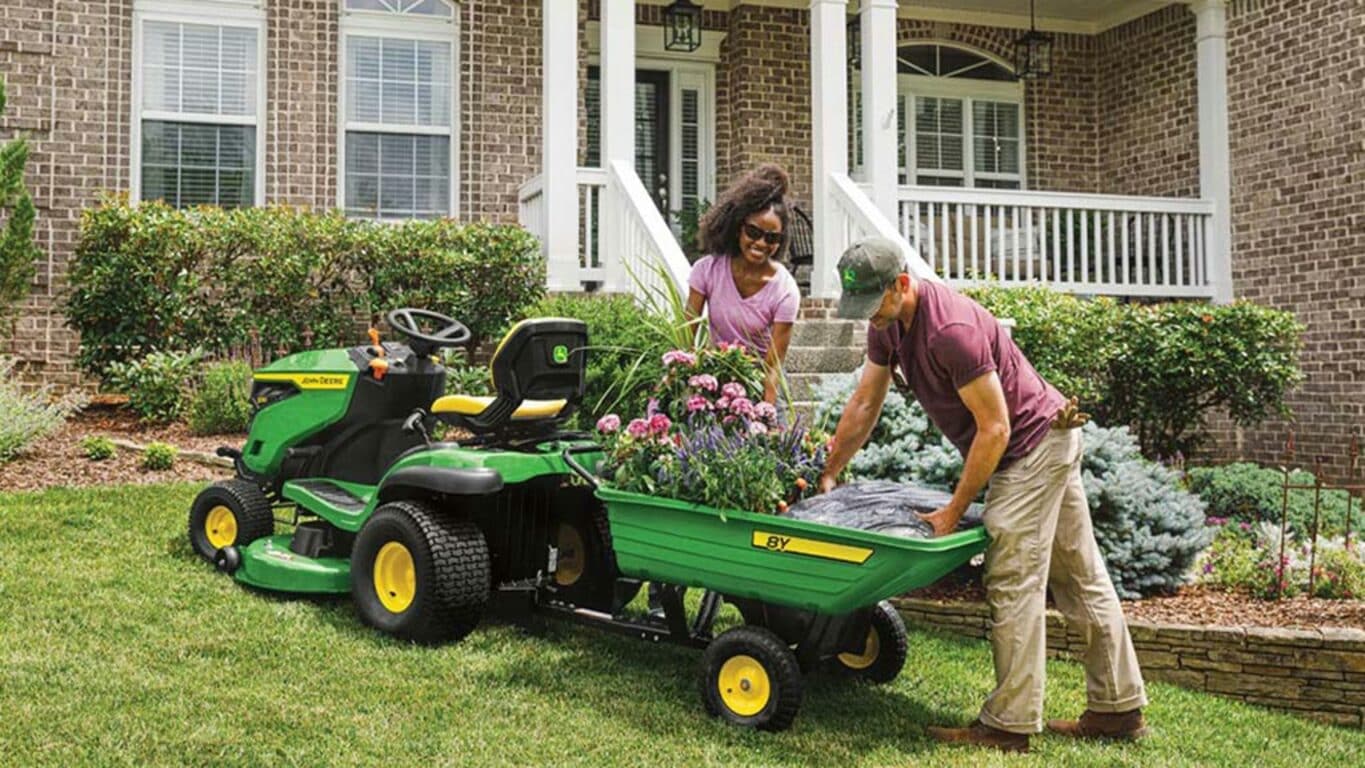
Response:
[128,0,266,206]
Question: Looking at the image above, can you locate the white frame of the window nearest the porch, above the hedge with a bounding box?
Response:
[336,0,461,221]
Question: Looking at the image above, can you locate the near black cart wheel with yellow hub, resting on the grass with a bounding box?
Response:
[702,626,801,731]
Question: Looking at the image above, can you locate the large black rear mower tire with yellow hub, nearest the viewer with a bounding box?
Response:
[351,501,490,644]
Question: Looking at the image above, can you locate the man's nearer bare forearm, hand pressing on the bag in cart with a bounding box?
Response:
[920,371,1010,536]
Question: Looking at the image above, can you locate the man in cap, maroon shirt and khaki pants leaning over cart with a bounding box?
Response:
[820,239,1147,752]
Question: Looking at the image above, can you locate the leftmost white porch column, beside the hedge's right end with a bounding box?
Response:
[541,0,581,291]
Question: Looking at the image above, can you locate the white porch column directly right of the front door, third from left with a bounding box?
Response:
[811,0,849,299]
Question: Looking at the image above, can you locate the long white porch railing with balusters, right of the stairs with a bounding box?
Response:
[900,187,1213,299]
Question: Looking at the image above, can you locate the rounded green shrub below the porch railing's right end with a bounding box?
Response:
[1106,303,1304,456]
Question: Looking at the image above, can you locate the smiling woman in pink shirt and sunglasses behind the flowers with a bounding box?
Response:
[687,165,801,405]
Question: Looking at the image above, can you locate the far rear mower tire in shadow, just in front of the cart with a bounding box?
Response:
[553,499,621,611]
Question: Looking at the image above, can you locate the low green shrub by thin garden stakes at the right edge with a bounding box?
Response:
[1188,464,1365,536]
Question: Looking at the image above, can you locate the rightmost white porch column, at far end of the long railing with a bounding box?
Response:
[1193,0,1233,304]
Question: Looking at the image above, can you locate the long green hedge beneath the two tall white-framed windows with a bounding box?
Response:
[64,198,545,374]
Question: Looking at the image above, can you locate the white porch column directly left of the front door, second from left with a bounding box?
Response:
[600,0,635,291]
